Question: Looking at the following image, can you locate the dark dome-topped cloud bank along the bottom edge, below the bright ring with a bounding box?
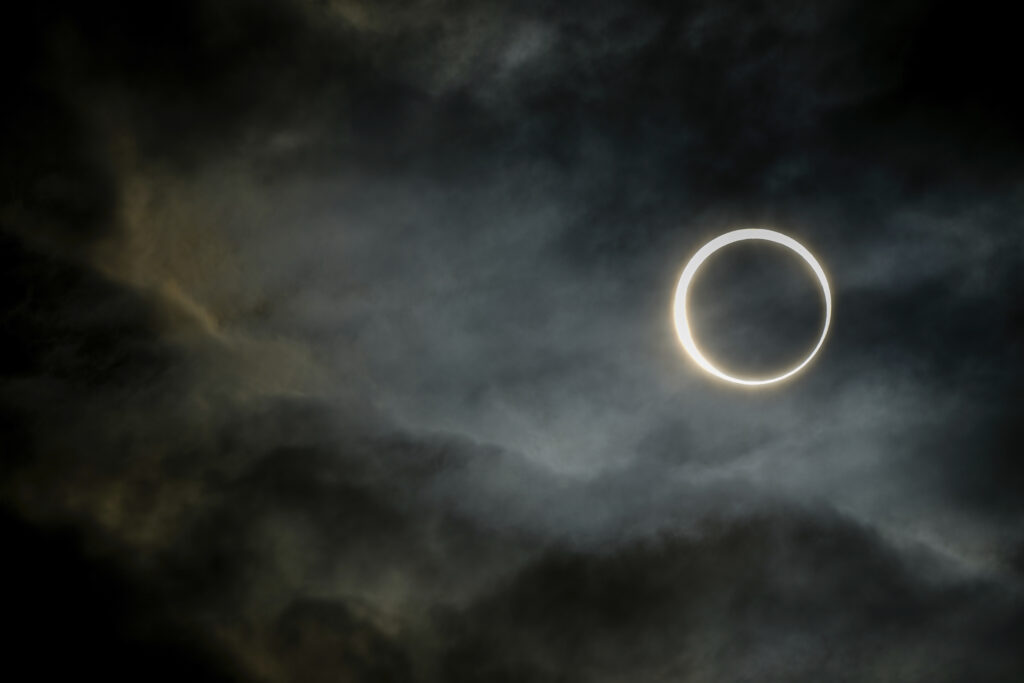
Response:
[445,510,1022,681]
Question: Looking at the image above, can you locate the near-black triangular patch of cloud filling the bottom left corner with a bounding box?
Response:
[0,512,239,682]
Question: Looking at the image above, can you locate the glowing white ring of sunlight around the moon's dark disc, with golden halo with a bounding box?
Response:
[675,228,831,386]
